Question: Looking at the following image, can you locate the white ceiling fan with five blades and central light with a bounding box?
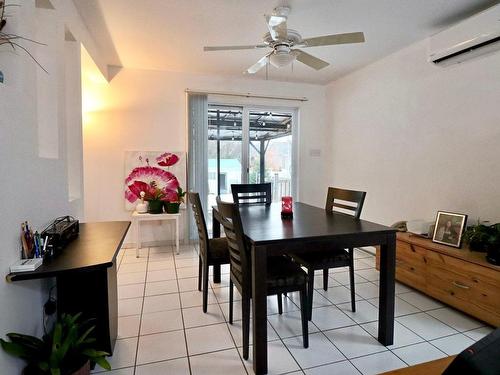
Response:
[203,6,365,74]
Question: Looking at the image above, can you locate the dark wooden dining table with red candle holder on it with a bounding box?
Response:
[212,203,396,374]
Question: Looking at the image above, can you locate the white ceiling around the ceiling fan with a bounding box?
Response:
[80,0,498,84]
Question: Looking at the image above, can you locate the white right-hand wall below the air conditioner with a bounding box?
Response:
[327,40,500,224]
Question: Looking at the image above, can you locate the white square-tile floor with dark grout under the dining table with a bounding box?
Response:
[95,246,492,375]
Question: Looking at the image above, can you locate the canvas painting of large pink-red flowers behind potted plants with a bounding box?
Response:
[124,151,186,210]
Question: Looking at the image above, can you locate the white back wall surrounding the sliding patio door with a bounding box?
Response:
[84,69,329,242]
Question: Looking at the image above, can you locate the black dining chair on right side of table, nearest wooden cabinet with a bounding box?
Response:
[292,187,366,320]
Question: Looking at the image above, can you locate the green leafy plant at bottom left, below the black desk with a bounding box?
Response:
[0,313,111,375]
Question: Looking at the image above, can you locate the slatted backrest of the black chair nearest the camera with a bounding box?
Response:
[217,197,251,288]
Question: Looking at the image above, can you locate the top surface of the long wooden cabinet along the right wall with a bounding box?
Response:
[397,232,500,271]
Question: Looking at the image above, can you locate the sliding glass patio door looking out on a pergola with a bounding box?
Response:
[206,104,296,213]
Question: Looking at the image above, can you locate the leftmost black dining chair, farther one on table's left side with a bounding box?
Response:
[188,192,229,313]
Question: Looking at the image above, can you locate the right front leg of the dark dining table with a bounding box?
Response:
[378,233,396,346]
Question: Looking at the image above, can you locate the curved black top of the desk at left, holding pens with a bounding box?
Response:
[7,221,130,281]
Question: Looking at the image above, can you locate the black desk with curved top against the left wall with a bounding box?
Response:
[6,221,130,353]
